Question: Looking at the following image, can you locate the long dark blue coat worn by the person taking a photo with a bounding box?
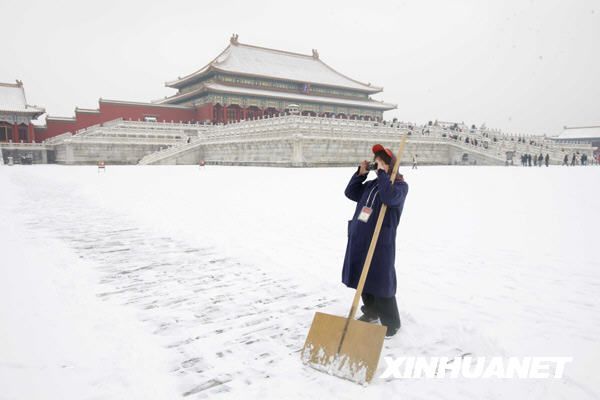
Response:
[342,170,408,297]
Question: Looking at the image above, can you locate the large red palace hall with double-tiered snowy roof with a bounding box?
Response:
[159,35,396,123]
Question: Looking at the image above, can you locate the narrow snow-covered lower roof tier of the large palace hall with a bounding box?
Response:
[163,83,396,110]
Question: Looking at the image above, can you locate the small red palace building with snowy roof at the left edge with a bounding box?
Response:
[0,81,45,143]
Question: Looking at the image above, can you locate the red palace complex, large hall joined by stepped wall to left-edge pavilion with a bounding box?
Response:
[14,35,396,142]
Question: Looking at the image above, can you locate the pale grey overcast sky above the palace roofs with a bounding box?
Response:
[0,0,600,134]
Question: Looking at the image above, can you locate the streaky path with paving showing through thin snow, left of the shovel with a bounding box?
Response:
[15,180,346,397]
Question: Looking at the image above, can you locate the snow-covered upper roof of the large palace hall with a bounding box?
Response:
[166,38,383,93]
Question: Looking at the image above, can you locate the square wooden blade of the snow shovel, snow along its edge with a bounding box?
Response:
[302,312,386,383]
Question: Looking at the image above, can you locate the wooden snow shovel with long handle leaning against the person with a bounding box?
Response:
[301,134,406,383]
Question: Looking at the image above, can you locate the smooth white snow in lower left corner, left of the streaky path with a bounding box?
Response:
[0,171,178,399]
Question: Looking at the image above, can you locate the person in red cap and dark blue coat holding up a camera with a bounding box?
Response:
[342,144,408,336]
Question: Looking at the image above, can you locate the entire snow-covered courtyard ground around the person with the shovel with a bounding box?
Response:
[0,165,600,399]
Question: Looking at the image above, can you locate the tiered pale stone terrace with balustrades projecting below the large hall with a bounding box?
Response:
[138,116,520,166]
